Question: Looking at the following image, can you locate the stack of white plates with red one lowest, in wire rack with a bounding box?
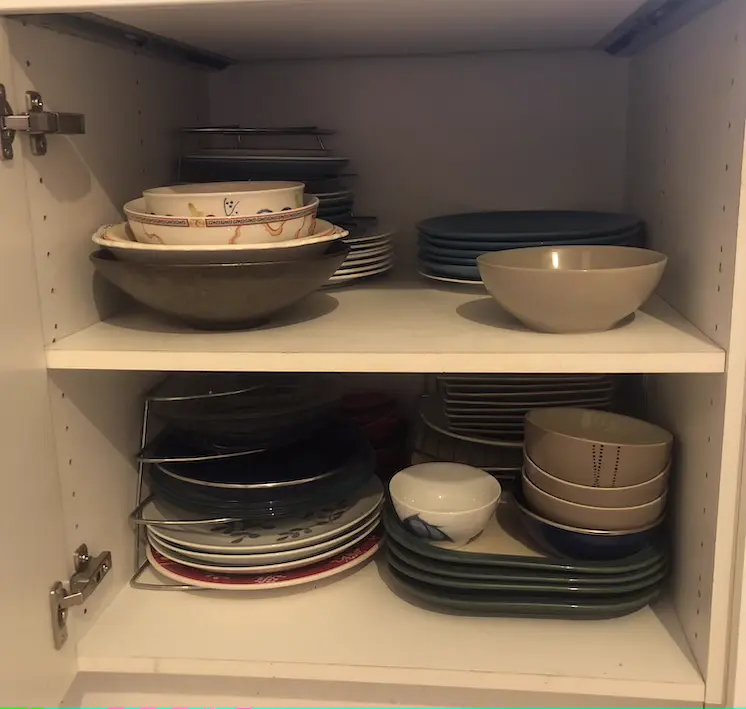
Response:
[143,477,383,590]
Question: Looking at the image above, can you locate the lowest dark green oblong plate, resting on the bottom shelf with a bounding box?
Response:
[389,566,660,620]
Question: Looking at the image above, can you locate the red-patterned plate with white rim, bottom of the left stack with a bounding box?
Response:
[146,531,383,591]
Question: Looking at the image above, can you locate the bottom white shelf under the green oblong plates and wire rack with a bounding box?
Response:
[78,561,704,702]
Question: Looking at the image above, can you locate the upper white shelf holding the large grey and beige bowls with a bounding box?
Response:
[47,282,725,373]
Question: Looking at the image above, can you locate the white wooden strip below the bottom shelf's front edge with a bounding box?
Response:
[64,673,702,709]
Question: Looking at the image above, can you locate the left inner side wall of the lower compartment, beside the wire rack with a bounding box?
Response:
[50,371,162,640]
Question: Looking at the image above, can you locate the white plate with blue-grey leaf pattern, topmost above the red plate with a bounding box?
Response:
[142,475,383,554]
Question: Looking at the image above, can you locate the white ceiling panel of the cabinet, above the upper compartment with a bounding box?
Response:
[7,0,644,60]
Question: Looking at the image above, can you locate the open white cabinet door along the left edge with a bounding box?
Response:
[0,20,76,707]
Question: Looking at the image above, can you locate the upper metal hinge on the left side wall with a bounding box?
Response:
[0,84,85,160]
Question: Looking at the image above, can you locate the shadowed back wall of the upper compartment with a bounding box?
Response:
[210,52,627,271]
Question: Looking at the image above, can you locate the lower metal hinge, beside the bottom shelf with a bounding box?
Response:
[49,544,111,650]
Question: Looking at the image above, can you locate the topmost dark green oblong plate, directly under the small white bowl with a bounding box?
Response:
[383,495,667,577]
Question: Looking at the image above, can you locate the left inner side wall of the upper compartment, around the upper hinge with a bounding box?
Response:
[3,22,206,344]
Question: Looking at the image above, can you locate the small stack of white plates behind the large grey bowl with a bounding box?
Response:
[329,220,394,285]
